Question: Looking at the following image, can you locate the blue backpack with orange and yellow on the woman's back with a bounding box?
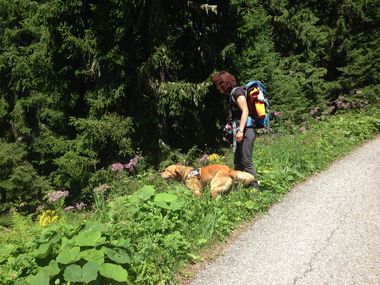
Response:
[243,80,270,129]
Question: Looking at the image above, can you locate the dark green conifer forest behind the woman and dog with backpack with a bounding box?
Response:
[0,0,380,212]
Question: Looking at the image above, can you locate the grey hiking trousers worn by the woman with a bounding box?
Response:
[233,128,257,180]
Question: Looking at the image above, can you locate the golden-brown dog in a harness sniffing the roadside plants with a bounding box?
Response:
[161,164,255,198]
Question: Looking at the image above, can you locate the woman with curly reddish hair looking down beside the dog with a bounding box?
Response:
[211,71,259,188]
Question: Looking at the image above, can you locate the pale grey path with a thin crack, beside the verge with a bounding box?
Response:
[191,136,380,285]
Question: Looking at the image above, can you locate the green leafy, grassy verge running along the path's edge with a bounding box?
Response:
[0,109,380,284]
